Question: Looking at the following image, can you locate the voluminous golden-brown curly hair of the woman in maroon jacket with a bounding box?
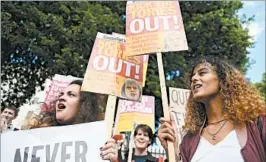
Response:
[184,56,266,133]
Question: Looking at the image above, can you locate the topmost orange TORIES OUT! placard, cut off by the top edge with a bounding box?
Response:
[126,1,188,56]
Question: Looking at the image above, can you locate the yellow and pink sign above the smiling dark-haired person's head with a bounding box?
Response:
[115,96,155,134]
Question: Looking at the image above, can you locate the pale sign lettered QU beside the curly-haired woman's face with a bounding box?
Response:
[169,87,190,143]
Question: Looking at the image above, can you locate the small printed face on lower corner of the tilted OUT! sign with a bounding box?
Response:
[121,78,142,101]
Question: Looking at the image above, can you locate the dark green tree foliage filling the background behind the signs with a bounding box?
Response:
[1,1,252,106]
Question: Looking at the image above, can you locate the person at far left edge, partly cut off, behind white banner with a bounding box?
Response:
[0,106,19,132]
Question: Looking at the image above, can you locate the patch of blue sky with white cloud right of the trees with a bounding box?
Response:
[238,1,265,83]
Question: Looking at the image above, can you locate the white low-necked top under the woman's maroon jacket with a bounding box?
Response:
[191,130,244,162]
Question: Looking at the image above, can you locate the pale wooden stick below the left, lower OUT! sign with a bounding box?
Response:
[104,95,116,138]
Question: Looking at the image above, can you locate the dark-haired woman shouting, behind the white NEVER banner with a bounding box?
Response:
[22,80,105,129]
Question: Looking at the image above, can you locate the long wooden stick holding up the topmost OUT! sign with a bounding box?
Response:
[157,52,176,162]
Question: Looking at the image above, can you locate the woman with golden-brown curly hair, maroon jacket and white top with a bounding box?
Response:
[158,57,266,162]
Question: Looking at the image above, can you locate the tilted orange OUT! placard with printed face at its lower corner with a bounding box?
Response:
[81,32,146,101]
